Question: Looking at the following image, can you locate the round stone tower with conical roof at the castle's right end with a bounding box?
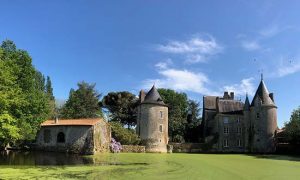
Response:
[250,79,277,153]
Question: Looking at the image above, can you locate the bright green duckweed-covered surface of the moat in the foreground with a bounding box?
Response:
[0,153,300,180]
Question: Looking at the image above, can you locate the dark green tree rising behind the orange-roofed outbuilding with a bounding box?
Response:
[61,82,102,119]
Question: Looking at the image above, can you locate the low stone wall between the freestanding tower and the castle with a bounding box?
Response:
[169,143,205,153]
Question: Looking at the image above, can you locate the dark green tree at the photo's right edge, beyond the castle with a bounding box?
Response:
[284,107,300,144]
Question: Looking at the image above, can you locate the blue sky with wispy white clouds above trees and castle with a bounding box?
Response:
[0,0,300,127]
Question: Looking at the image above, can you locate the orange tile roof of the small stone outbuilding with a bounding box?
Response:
[41,118,103,126]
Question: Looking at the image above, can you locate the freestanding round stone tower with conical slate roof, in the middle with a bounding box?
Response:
[136,86,168,152]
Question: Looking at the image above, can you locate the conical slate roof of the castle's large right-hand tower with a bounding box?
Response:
[251,80,274,106]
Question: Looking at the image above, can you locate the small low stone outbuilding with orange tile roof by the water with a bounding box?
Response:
[37,118,111,154]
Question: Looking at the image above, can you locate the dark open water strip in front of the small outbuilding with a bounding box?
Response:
[0,151,94,166]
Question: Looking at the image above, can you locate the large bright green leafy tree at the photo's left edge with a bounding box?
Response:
[0,40,50,146]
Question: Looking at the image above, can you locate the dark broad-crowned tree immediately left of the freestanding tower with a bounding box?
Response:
[102,91,138,127]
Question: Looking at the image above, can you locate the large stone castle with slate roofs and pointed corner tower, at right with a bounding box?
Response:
[202,79,277,153]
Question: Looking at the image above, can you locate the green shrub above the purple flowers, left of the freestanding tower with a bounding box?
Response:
[110,122,140,145]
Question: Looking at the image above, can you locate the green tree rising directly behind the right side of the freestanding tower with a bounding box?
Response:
[158,89,188,142]
